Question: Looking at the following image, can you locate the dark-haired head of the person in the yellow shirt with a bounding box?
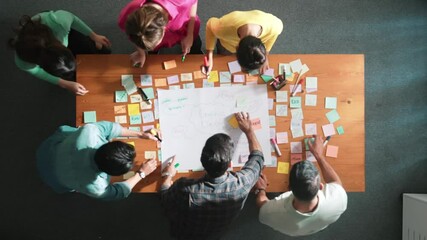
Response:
[236,36,267,71]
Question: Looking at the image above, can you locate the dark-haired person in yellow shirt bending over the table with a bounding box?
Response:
[206,10,283,73]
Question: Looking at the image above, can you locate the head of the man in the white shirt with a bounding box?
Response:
[289,160,320,202]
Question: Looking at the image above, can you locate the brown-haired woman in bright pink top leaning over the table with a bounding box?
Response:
[119,0,203,67]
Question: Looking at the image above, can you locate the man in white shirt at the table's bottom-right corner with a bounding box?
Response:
[255,135,347,236]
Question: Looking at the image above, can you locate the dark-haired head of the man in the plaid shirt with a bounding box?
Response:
[200,133,234,178]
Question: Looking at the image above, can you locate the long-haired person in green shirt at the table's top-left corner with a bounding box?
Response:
[9,10,111,95]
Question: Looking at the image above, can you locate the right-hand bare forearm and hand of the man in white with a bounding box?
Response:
[308,135,342,186]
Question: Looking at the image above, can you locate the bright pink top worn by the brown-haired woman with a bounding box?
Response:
[119,0,200,50]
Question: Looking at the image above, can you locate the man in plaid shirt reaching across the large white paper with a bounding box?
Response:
[160,112,264,239]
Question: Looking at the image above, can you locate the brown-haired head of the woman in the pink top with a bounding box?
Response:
[125,5,169,51]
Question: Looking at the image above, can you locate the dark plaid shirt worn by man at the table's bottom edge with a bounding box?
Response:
[161,151,264,239]
